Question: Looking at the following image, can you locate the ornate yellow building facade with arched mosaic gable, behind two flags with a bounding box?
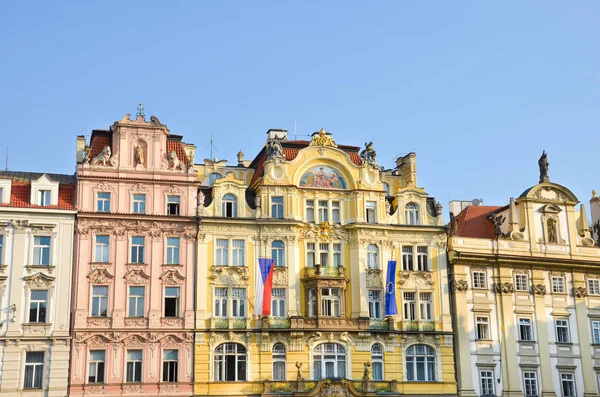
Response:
[194,130,457,396]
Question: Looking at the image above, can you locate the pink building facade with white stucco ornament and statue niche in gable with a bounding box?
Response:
[70,112,198,396]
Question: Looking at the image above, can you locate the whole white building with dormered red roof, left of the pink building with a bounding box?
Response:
[0,172,75,397]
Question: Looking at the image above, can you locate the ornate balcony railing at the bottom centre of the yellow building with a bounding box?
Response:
[262,375,400,397]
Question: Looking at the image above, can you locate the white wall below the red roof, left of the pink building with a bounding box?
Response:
[0,207,75,397]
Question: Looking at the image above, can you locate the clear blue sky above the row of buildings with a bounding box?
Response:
[0,0,600,216]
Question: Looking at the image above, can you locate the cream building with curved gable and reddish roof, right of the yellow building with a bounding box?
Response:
[449,171,600,396]
